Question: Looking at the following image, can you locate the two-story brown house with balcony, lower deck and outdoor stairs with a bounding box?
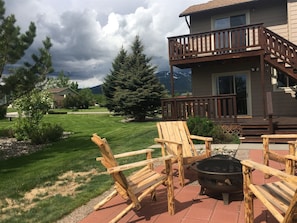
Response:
[162,0,297,139]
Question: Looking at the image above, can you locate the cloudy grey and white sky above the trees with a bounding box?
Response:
[4,0,207,88]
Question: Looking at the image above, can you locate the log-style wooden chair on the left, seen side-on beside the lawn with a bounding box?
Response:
[91,134,175,222]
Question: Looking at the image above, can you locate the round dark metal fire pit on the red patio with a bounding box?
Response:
[191,155,242,204]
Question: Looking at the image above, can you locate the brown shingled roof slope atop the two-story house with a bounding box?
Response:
[179,0,259,17]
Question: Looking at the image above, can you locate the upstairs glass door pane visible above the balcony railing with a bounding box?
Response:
[214,14,246,30]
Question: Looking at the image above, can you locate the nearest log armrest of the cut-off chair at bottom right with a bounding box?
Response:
[241,160,297,184]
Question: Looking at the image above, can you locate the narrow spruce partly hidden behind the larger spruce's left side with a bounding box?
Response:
[102,47,127,112]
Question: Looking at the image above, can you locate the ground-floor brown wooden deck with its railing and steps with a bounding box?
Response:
[161,95,297,142]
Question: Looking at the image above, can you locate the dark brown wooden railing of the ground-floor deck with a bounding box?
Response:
[161,94,237,122]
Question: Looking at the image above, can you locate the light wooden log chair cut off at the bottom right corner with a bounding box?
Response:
[241,159,297,223]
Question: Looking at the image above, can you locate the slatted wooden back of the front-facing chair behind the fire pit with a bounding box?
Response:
[157,121,197,157]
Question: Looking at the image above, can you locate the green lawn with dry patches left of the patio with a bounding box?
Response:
[0,114,157,223]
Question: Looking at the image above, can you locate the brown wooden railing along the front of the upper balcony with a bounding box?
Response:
[168,24,264,65]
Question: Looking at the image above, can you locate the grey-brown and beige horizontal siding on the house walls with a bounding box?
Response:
[190,0,297,117]
